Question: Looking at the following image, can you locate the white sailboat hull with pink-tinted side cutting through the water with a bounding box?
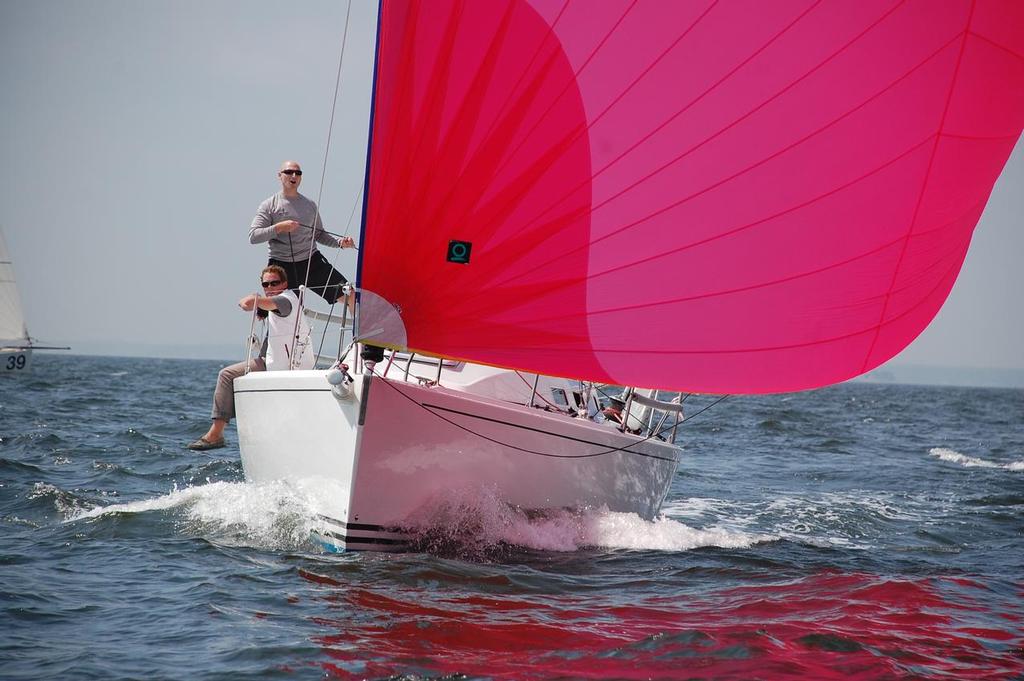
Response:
[234,371,679,550]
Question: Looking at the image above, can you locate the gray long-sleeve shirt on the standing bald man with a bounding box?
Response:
[249,191,338,262]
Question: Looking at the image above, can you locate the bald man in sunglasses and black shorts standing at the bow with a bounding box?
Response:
[249,161,355,304]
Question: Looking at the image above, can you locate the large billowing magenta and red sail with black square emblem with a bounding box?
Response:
[360,0,1024,393]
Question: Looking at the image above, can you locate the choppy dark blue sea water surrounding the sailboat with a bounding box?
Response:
[0,355,1024,680]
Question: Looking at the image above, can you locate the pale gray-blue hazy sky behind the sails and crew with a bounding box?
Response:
[0,0,1024,378]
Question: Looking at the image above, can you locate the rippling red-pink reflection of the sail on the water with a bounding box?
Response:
[303,572,1024,680]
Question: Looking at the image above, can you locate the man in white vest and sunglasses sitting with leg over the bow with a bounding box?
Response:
[188,265,313,452]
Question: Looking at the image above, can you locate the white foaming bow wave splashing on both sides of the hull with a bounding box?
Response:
[67,481,775,559]
